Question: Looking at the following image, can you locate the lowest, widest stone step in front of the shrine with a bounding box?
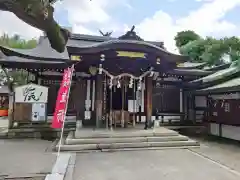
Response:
[56,140,199,151]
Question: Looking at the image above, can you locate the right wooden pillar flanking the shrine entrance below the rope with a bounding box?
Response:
[144,77,153,129]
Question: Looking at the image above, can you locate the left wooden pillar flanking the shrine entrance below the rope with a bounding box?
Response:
[95,74,103,128]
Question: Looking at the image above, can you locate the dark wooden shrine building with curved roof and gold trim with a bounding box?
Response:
[0,28,218,129]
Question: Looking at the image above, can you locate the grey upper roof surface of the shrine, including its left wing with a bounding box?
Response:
[0,34,188,62]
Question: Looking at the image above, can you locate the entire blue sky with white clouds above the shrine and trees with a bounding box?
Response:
[0,0,240,51]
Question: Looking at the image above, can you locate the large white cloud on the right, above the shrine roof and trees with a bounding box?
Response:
[137,0,240,52]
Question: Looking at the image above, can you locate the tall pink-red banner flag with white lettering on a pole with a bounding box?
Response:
[52,66,74,129]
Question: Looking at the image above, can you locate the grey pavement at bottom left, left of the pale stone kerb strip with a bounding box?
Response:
[0,139,56,179]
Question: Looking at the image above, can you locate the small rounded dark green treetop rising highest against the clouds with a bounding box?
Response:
[174,30,201,48]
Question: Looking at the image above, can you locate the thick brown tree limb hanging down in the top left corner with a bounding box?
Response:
[0,0,70,53]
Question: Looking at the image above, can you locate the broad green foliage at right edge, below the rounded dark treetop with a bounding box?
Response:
[176,31,240,65]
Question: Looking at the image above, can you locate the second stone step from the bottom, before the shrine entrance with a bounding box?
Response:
[65,135,188,145]
